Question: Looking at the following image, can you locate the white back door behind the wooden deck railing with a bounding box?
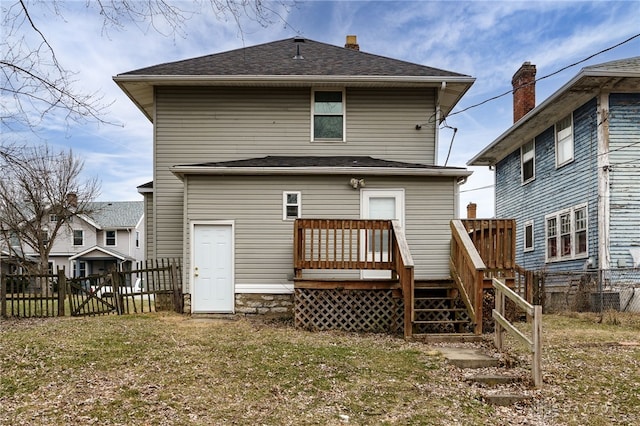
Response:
[360,189,404,278]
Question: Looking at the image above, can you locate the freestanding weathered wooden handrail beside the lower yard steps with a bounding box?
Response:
[492,278,542,388]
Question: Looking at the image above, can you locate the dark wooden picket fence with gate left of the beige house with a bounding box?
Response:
[0,259,183,318]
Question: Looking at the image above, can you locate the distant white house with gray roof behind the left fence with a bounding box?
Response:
[9,201,144,277]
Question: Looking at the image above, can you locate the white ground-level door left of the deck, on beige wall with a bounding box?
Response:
[191,224,234,313]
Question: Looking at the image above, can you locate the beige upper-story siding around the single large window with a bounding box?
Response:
[154,87,435,257]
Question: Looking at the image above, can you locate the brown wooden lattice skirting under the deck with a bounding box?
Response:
[295,288,404,333]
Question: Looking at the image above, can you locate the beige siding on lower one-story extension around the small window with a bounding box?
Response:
[185,175,455,289]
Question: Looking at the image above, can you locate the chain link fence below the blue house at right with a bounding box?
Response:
[535,268,640,313]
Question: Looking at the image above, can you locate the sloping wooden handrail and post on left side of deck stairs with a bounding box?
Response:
[391,220,415,338]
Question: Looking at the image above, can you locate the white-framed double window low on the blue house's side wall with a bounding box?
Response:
[544,203,589,263]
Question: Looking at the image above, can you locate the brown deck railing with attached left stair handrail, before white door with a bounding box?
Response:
[293,219,414,337]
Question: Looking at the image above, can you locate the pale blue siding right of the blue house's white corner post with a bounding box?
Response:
[609,93,640,267]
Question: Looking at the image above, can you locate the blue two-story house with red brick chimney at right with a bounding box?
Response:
[468,57,640,272]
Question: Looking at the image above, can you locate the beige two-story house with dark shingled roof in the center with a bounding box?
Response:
[114,36,474,312]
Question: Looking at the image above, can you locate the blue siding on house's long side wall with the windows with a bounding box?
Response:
[496,99,598,271]
